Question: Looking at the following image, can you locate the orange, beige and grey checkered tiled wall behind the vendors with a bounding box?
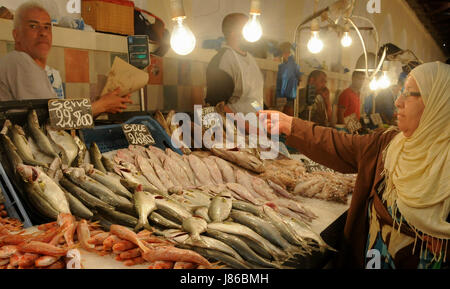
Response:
[0,41,276,112]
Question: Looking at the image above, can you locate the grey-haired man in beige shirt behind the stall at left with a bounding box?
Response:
[0,2,132,117]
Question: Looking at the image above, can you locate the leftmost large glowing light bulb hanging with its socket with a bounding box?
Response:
[170,0,196,55]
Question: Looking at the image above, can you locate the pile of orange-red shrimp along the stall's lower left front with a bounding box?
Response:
[0,214,221,269]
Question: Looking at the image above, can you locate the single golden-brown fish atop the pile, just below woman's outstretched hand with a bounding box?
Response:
[211,147,265,173]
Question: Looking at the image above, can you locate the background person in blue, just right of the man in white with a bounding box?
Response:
[276,42,302,116]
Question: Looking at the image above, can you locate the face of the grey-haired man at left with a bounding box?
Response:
[13,9,52,61]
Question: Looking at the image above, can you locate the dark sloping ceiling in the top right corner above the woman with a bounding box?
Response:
[406,0,450,57]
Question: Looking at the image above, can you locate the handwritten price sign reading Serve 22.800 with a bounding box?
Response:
[48,98,94,130]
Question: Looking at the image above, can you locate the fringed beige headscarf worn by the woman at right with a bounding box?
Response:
[383,62,450,250]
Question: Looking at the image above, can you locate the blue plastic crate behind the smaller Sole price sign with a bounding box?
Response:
[80,116,183,155]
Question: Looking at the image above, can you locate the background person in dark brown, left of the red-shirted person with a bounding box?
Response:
[298,70,332,126]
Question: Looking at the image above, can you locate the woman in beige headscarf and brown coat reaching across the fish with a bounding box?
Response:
[261,62,450,268]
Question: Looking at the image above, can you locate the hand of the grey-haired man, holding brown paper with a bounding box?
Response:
[92,88,133,118]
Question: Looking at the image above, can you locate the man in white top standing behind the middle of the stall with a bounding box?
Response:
[205,13,264,114]
